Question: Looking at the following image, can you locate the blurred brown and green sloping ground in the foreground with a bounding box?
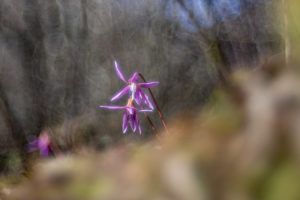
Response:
[1,60,300,200]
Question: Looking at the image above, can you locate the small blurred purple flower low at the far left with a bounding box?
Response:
[27,131,51,157]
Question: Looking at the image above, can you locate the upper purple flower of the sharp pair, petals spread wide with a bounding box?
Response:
[111,61,159,110]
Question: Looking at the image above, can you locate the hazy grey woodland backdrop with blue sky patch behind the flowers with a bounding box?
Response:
[0,0,280,156]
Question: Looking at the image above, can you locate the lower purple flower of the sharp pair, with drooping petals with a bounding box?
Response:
[100,98,152,135]
